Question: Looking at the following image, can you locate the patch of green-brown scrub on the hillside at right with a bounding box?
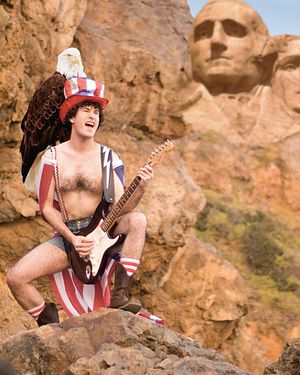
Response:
[196,191,300,314]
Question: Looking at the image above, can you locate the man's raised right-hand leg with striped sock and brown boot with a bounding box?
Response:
[110,212,147,313]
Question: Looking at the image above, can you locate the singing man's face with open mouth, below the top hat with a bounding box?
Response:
[71,105,100,138]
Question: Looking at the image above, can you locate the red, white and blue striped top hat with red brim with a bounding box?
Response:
[59,77,108,122]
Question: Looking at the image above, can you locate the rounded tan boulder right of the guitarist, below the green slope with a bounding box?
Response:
[147,238,247,348]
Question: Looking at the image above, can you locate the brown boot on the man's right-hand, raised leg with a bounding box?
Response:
[109,263,142,314]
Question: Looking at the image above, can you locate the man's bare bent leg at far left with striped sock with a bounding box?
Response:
[6,242,68,325]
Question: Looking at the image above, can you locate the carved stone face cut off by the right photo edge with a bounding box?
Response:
[272,39,300,115]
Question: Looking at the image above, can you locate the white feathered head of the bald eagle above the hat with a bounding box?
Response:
[56,48,86,79]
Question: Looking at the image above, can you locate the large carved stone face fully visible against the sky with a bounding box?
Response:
[191,1,260,92]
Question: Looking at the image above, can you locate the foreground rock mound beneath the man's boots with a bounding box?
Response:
[0,309,250,375]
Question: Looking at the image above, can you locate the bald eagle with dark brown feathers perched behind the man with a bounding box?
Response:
[20,48,86,182]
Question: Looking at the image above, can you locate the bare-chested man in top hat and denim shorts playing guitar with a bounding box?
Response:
[7,78,153,325]
